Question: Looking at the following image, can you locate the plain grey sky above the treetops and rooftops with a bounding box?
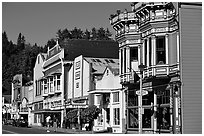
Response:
[2,2,131,46]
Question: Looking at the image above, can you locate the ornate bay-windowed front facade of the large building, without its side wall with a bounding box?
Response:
[110,2,202,133]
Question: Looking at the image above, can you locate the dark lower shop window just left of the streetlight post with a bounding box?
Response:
[128,108,139,128]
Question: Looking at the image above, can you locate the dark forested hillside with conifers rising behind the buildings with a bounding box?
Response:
[2,27,113,94]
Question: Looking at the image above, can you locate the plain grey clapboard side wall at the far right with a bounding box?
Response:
[180,5,202,134]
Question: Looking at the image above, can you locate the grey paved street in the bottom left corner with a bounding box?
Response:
[2,125,66,134]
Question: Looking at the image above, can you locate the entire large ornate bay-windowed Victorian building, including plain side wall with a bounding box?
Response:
[110,2,202,133]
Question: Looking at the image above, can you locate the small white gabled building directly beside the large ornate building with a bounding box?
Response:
[89,59,125,133]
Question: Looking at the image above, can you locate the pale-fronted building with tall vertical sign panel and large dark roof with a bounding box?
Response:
[32,40,118,127]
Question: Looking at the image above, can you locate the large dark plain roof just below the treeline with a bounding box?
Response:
[60,39,119,61]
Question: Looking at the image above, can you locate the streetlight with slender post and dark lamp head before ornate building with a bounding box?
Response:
[138,63,146,134]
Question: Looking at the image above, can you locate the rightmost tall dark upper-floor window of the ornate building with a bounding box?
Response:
[156,36,166,65]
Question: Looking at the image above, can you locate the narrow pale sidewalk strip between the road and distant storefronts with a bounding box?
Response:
[31,126,94,134]
